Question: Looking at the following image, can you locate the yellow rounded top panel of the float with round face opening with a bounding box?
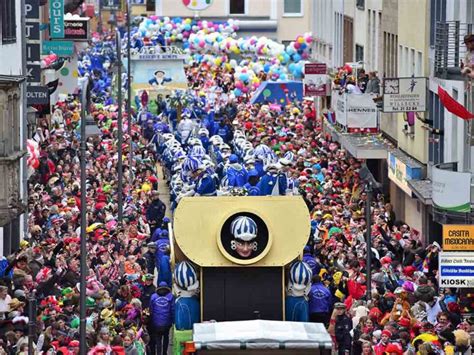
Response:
[173,196,311,267]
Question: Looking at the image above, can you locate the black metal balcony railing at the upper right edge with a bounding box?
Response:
[434,21,472,80]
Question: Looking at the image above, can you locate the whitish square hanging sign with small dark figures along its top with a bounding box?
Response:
[383,77,427,112]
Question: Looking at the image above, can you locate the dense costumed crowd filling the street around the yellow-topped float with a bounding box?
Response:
[0,15,474,355]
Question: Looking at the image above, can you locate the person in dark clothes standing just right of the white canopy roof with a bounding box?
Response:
[328,302,352,355]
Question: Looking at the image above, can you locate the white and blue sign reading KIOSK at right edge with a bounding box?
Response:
[439,252,474,288]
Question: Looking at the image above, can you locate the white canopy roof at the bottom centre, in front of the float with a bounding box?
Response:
[193,319,332,350]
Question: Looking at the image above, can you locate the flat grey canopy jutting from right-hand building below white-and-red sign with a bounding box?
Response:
[325,122,391,159]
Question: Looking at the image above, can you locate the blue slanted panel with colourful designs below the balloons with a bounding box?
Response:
[250,81,303,105]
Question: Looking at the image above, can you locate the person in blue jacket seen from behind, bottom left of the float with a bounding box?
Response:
[149,281,175,355]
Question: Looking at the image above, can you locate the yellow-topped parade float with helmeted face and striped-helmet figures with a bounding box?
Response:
[169,196,331,354]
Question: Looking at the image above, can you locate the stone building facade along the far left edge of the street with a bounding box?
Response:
[0,0,26,255]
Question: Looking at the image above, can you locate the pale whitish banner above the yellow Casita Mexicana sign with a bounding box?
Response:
[431,166,471,213]
